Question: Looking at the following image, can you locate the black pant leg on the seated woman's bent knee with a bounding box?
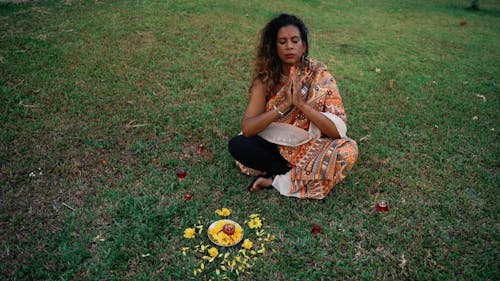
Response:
[228,135,290,175]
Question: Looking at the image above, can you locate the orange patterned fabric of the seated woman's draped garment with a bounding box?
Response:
[240,59,358,199]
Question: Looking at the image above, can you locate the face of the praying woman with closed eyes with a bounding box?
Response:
[276,25,307,66]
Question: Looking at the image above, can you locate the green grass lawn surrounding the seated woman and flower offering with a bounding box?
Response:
[0,0,500,280]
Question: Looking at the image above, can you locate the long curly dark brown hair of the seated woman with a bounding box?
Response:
[253,14,309,97]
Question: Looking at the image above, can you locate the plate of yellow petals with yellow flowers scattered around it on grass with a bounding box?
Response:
[181,208,275,280]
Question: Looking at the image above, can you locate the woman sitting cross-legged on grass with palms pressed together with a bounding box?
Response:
[229,14,358,199]
